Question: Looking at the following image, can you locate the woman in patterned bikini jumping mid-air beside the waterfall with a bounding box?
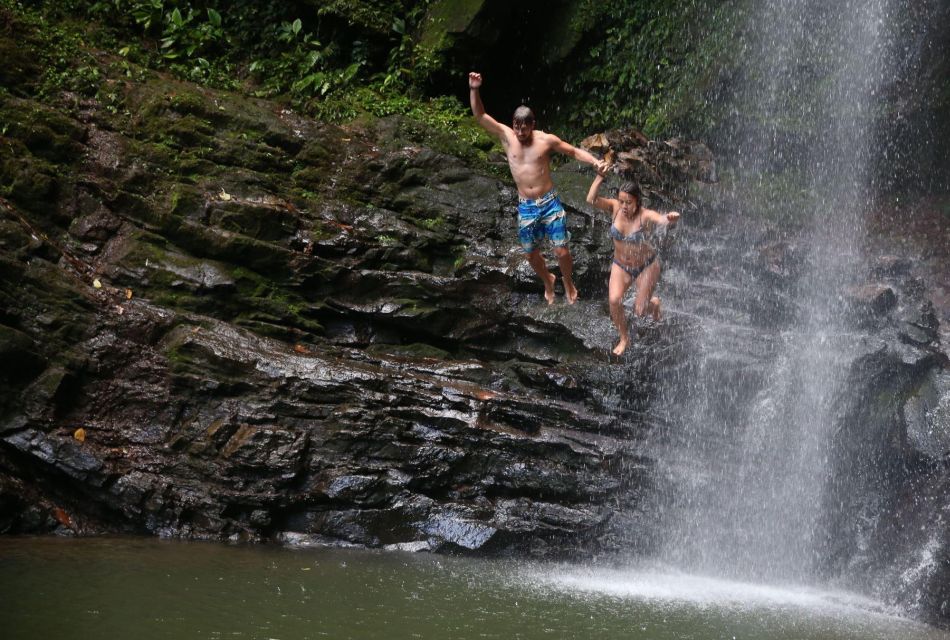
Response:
[587,169,680,356]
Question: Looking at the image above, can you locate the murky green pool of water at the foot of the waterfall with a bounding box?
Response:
[0,538,950,640]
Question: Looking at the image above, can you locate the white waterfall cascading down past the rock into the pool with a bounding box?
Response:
[654,0,900,584]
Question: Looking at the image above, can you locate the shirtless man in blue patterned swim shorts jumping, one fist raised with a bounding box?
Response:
[468,72,604,304]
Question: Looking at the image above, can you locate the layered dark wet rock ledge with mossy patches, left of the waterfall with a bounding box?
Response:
[0,58,708,555]
